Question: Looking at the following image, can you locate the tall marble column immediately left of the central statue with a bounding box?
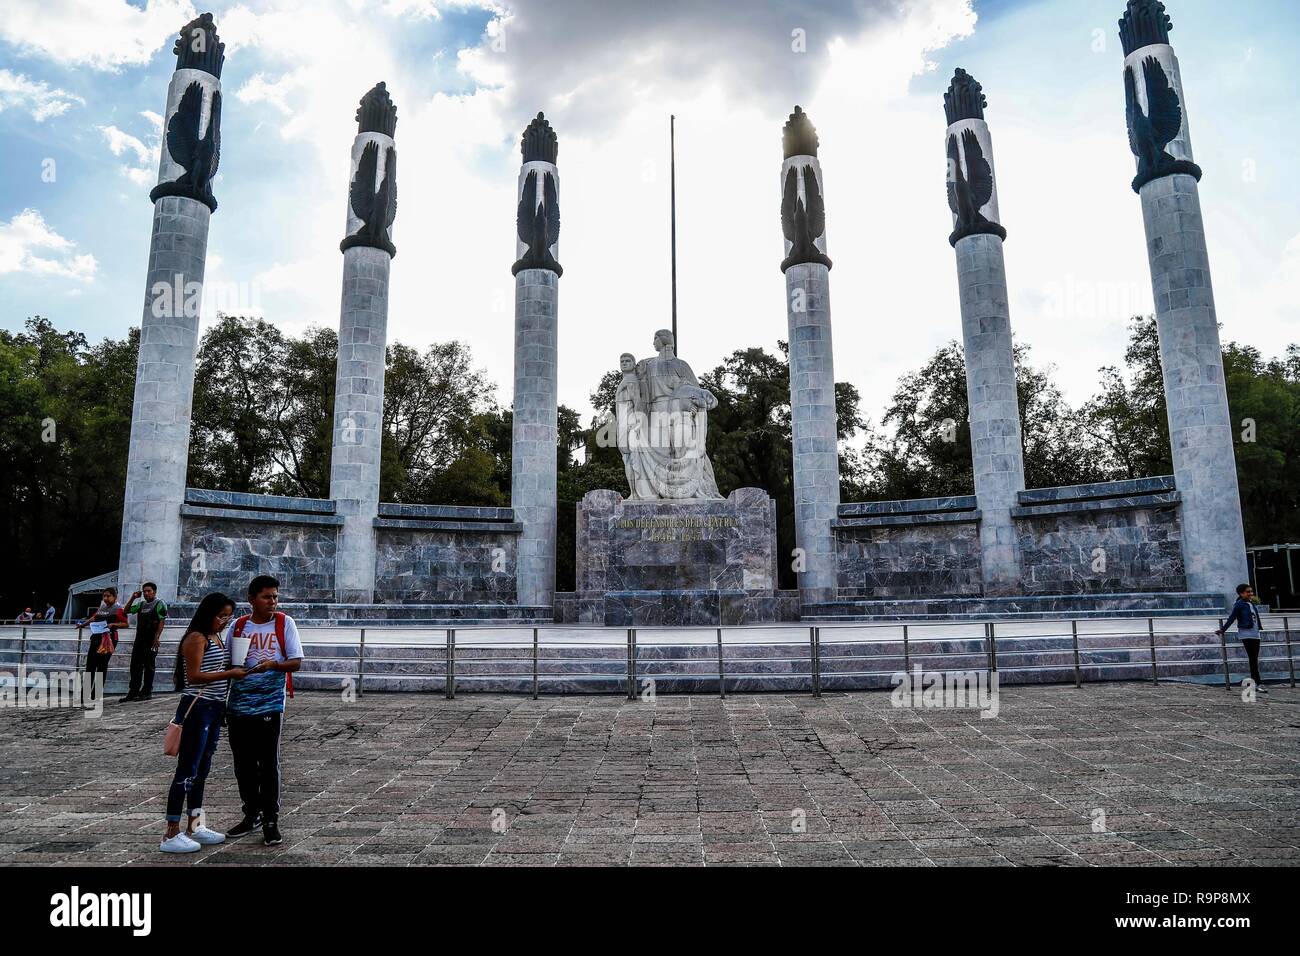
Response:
[510,113,564,607]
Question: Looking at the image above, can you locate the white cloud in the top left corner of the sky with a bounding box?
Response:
[0,0,195,70]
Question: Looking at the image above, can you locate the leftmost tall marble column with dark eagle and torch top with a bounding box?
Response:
[118,13,225,601]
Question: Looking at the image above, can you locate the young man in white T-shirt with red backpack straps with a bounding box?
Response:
[226,575,303,847]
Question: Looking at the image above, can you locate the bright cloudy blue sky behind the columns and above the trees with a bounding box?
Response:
[0,0,1300,418]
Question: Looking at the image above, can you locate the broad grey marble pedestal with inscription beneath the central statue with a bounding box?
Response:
[577,488,777,627]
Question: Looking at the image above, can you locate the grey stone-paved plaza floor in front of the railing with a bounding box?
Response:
[0,683,1300,866]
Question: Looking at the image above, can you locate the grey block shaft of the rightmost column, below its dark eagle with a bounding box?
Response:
[1140,174,1249,601]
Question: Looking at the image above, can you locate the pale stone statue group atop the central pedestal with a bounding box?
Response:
[615,329,723,501]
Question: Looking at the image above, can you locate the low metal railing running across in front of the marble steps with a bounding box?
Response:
[0,615,1296,700]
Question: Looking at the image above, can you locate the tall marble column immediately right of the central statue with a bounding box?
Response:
[781,107,840,604]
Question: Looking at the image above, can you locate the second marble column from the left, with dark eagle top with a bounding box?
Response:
[329,83,398,604]
